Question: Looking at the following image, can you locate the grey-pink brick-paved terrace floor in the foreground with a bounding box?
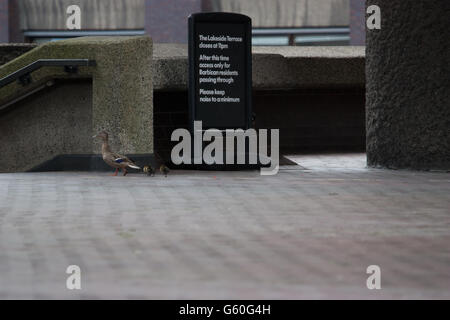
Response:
[0,154,450,299]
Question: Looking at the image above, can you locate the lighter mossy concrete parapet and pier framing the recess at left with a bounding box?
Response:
[0,37,153,170]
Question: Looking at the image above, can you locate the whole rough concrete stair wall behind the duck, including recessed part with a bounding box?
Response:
[0,37,153,172]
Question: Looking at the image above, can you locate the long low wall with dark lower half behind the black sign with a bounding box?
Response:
[153,44,366,159]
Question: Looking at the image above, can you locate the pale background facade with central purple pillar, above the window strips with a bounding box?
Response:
[0,0,350,43]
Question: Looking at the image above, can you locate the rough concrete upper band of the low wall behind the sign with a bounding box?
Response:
[153,44,365,90]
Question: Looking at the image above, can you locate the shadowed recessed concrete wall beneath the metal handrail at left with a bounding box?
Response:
[0,80,92,172]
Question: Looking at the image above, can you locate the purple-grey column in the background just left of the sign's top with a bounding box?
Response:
[145,0,208,43]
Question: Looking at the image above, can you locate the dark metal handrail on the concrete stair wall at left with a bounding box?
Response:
[0,59,96,88]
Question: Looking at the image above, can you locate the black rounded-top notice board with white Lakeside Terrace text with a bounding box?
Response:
[189,12,252,129]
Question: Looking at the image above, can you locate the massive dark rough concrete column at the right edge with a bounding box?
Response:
[366,0,450,170]
